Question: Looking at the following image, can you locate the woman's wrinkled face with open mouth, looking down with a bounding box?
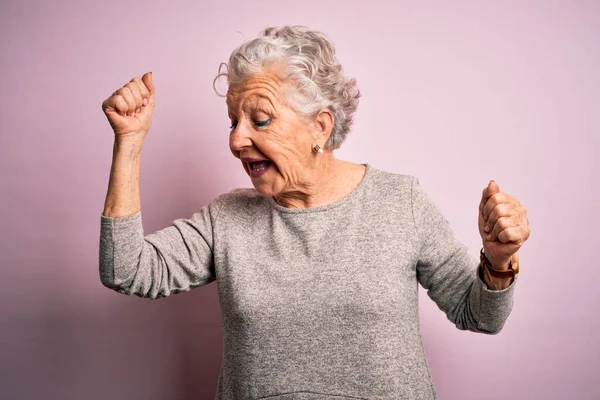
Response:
[227,71,320,196]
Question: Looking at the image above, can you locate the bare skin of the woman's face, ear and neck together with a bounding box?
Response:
[226,67,366,208]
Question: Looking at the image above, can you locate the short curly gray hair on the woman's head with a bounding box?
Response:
[213,25,360,150]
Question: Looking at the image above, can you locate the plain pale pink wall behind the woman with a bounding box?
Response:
[0,0,600,400]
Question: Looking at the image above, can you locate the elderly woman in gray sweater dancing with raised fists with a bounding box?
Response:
[100,26,529,399]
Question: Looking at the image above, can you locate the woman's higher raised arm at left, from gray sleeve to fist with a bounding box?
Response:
[99,73,217,299]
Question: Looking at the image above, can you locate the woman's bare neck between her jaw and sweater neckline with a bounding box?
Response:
[273,151,351,208]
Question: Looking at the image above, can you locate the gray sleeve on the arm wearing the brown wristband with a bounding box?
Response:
[412,177,518,334]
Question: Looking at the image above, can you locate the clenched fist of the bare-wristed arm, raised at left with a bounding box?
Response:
[102,72,154,139]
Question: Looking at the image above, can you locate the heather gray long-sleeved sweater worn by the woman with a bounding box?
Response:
[99,164,517,400]
